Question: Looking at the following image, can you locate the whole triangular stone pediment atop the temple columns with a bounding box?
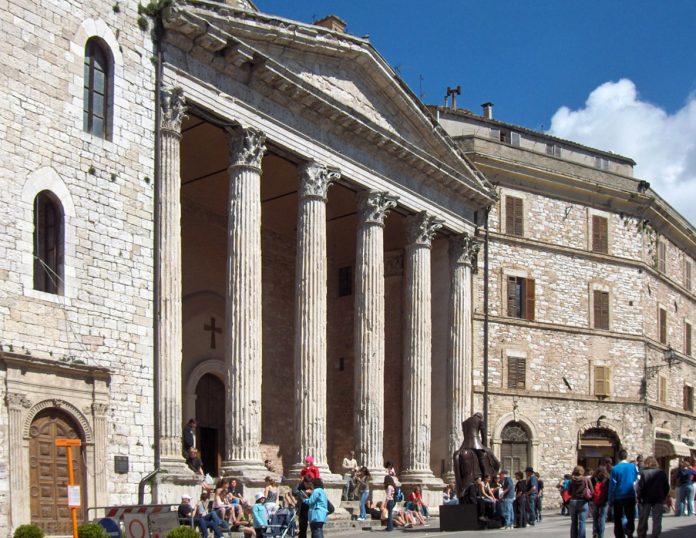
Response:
[164,2,490,203]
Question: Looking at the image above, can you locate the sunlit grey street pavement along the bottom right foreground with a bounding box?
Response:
[326,514,696,538]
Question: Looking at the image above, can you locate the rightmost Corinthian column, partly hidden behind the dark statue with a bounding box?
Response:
[445,229,480,481]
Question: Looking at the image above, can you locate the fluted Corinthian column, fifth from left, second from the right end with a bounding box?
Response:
[402,211,442,486]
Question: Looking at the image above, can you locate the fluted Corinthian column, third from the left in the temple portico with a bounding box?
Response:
[293,162,340,477]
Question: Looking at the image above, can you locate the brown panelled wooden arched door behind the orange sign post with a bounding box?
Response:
[29,408,86,535]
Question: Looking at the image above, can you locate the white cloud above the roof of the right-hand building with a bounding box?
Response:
[549,79,696,224]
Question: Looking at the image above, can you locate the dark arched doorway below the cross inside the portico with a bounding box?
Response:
[196,374,225,476]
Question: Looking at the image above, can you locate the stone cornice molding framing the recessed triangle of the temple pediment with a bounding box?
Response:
[163,4,495,207]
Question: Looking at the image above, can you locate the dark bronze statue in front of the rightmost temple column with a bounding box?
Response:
[453,413,500,498]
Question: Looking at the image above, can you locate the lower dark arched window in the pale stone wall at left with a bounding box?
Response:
[34,191,63,294]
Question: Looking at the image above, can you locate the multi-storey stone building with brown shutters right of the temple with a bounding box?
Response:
[432,103,696,480]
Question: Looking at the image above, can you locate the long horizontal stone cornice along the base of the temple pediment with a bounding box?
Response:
[163,2,495,207]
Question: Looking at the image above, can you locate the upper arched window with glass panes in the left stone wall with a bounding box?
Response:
[83,38,113,138]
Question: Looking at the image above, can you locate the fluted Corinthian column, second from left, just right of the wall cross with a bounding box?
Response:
[223,128,266,482]
